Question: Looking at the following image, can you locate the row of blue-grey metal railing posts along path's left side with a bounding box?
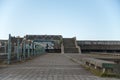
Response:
[0,34,45,64]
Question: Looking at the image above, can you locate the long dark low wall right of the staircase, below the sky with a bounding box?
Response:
[77,40,120,53]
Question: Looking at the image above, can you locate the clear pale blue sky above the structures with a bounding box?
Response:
[0,0,120,40]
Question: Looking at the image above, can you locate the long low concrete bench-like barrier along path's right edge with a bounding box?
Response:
[66,54,117,73]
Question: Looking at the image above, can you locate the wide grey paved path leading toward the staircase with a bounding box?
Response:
[0,53,119,80]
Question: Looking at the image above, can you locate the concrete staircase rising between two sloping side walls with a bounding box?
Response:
[63,38,80,53]
